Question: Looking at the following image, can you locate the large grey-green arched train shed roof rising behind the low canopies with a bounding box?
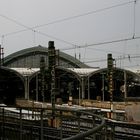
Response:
[4,45,89,68]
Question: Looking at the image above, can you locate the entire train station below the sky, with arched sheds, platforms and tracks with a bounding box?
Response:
[0,41,140,140]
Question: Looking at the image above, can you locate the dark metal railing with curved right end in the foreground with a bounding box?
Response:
[0,106,105,140]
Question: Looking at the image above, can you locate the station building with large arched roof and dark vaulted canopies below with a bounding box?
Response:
[0,46,140,104]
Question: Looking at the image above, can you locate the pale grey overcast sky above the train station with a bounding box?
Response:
[0,0,140,68]
